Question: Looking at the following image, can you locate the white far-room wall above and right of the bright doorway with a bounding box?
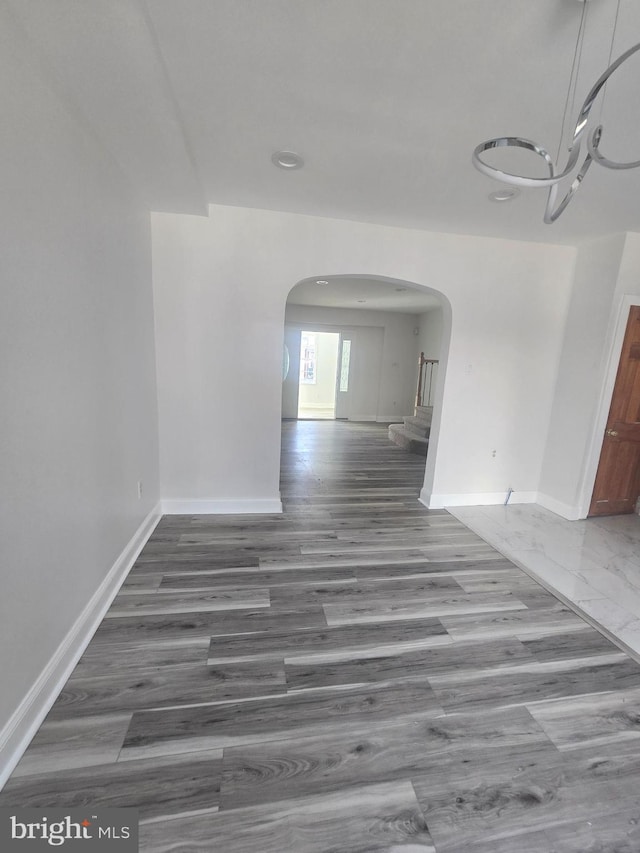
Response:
[285,305,418,421]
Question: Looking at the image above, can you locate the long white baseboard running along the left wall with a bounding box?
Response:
[0,504,161,789]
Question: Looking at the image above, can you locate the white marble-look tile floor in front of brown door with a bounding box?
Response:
[448,504,640,660]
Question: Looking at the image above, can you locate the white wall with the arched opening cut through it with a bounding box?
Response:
[153,206,575,510]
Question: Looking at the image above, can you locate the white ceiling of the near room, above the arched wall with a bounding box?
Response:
[5,0,640,243]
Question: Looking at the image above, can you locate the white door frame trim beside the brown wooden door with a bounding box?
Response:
[577,293,640,518]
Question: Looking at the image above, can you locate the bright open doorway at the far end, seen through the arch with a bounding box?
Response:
[298,329,340,420]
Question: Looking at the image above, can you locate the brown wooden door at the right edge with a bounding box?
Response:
[589,306,640,515]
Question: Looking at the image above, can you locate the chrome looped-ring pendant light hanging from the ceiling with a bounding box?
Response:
[472,0,640,220]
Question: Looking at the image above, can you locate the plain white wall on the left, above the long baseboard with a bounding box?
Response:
[0,11,159,785]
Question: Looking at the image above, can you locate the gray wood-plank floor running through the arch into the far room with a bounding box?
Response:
[0,422,640,853]
